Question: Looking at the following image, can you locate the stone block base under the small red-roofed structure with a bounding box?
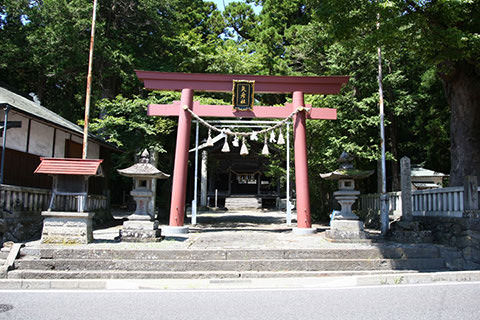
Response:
[41,211,95,244]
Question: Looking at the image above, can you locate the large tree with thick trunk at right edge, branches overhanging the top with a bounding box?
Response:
[314,0,480,186]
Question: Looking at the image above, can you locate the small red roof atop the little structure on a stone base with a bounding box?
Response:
[34,158,103,176]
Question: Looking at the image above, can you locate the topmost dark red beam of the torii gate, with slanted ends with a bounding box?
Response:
[135,70,349,94]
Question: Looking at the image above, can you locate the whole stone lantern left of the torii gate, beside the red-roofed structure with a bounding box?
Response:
[118,150,170,242]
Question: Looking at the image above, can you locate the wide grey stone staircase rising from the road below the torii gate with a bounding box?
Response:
[8,246,446,279]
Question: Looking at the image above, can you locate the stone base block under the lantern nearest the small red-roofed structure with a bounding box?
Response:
[120,220,163,242]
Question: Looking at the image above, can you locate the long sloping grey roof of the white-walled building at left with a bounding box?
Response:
[0,86,116,149]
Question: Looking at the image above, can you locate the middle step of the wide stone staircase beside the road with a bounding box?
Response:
[15,258,445,272]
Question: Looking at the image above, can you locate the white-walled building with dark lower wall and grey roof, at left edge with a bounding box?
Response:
[0,87,115,188]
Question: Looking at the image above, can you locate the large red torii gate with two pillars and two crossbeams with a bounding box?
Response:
[135,70,349,233]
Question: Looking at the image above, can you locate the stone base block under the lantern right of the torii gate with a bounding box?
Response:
[325,220,368,242]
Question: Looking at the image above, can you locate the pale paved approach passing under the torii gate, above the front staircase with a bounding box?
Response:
[31,211,382,250]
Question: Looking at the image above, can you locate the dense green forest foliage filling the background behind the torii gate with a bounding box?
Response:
[0,0,464,219]
